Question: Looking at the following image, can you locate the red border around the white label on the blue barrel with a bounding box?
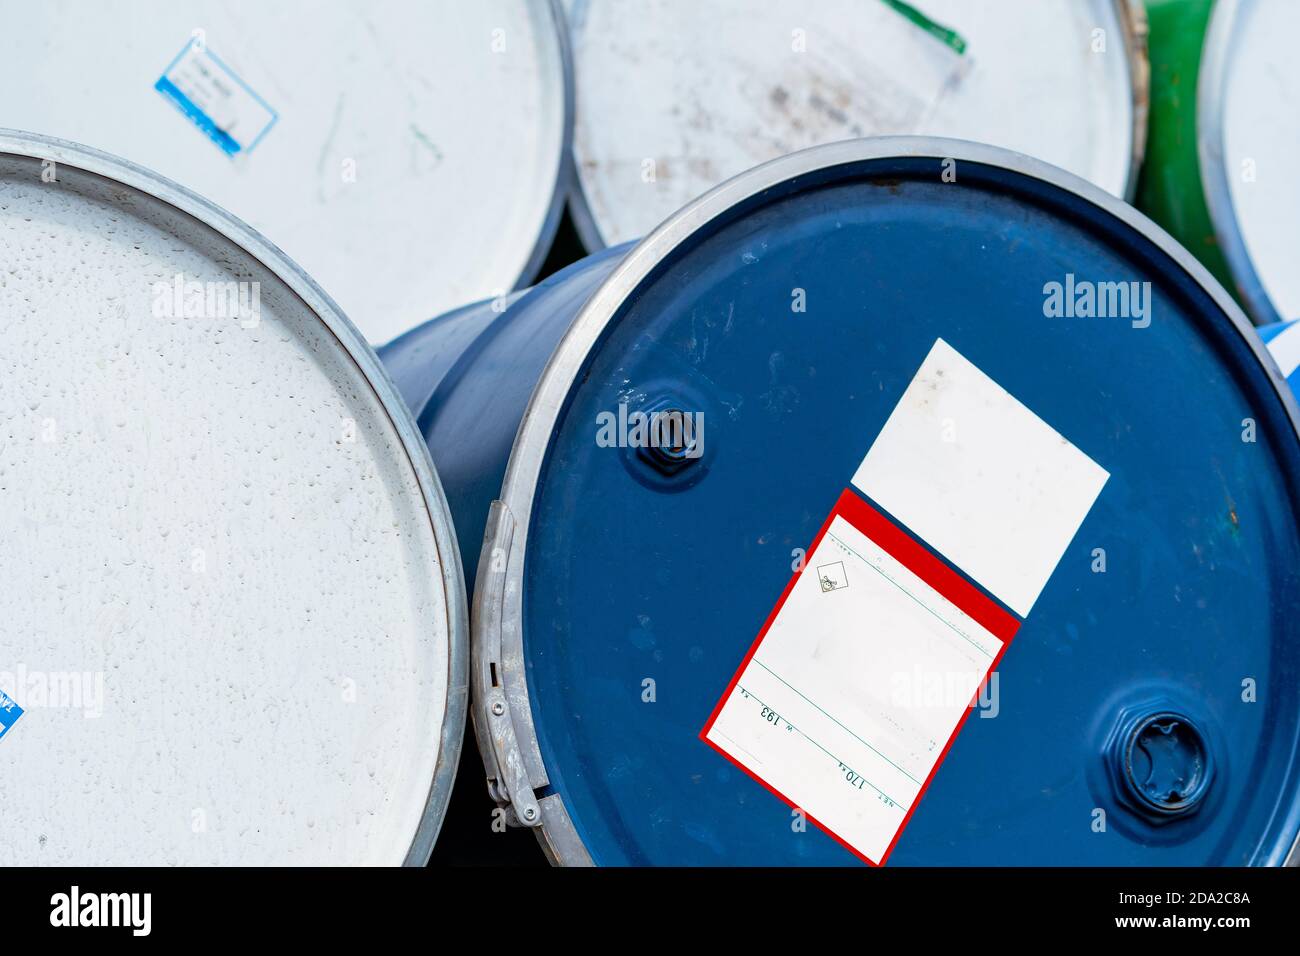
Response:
[699,488,1021,866]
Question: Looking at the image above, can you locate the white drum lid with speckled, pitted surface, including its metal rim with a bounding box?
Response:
[0,133,467,865]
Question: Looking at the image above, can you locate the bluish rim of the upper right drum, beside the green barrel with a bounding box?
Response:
[1196,0,1288,325]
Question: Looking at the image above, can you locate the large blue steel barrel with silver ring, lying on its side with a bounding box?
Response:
[382,139,1300,865]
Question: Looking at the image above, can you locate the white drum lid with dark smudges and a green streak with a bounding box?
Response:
[566,0,1147,248]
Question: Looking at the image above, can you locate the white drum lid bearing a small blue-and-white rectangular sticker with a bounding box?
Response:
[0,0,571,343]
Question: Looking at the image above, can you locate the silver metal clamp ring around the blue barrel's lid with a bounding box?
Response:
[486,128,1300,865]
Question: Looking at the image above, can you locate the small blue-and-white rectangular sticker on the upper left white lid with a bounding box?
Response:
[153,38,280,156]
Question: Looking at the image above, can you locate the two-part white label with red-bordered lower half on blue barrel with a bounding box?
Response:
[701,339,1109,865]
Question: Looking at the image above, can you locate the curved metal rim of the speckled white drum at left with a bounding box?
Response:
[0,127,469,866]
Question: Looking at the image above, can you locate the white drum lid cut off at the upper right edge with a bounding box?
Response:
[1197,0,1300,324]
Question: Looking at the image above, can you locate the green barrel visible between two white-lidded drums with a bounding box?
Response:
[1138,0,1242,300]
